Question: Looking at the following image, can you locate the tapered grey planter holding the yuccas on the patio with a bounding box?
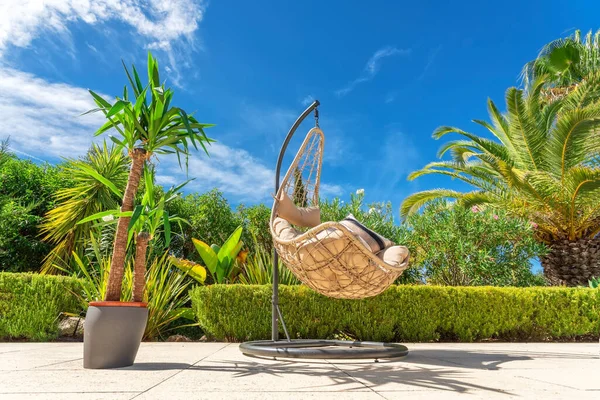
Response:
[83,301,148,369]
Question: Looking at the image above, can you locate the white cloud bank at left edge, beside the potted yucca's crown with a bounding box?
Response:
[0,68,104,159]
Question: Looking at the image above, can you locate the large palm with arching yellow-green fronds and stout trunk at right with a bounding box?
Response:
[401,73,600,285]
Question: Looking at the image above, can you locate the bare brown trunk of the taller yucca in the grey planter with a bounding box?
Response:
[104,148,146,301]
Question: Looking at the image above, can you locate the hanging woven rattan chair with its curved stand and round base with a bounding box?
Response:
[240,101,408,360]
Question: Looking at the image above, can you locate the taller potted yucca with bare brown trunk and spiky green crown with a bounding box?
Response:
[90,52,212,301]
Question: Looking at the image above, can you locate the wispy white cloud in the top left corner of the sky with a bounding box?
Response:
[0,0,205,83]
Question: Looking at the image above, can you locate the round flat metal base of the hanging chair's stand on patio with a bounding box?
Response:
[240,340,408,360]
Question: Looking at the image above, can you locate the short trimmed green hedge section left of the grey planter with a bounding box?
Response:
[0,273,80,341]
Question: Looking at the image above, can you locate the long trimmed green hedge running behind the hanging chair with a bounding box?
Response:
[191,285,600,342]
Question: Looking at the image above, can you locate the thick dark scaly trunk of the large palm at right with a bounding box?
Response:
[541,239,600,286]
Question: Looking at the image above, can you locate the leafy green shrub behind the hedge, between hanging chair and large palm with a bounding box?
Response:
[400,201,546,286]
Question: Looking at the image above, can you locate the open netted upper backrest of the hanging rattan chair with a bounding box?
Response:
[271,127,325,221]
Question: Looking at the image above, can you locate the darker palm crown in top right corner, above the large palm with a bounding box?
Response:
[521,30,600,97]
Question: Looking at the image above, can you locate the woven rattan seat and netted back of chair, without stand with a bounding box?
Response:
[270,128,406,299]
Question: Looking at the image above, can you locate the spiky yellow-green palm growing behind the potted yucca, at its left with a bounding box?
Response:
[40,142,128,273]
